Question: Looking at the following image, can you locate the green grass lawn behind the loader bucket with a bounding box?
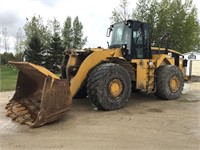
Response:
[0,66,60,92]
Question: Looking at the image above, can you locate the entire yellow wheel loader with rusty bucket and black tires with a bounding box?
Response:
[6,20,187,127]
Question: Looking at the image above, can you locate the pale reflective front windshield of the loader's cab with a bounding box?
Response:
[110,22,131,46]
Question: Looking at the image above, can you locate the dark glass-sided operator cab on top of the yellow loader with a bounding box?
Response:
[107,20,151,60]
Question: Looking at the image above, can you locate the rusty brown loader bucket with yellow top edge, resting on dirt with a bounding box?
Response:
[6,62,72,127]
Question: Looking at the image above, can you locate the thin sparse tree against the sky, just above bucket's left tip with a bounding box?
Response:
[15,28,24,61]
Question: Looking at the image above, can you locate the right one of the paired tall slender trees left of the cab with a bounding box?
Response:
[73,16,87,49]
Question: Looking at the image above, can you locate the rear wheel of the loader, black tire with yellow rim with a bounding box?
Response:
[155,65,184,100]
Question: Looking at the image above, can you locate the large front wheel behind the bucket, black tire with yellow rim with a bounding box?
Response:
[87,63,131,110]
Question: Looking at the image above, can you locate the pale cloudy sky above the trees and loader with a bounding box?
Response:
[0,0,200,53]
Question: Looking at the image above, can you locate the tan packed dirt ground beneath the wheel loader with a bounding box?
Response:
[0,82,200,150]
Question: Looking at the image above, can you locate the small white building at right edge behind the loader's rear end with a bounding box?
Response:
[183,52,200,76]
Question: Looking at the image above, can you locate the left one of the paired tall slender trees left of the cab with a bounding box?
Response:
[62,16,73,49]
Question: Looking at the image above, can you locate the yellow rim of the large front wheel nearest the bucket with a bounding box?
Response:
[108,79,123,98]
